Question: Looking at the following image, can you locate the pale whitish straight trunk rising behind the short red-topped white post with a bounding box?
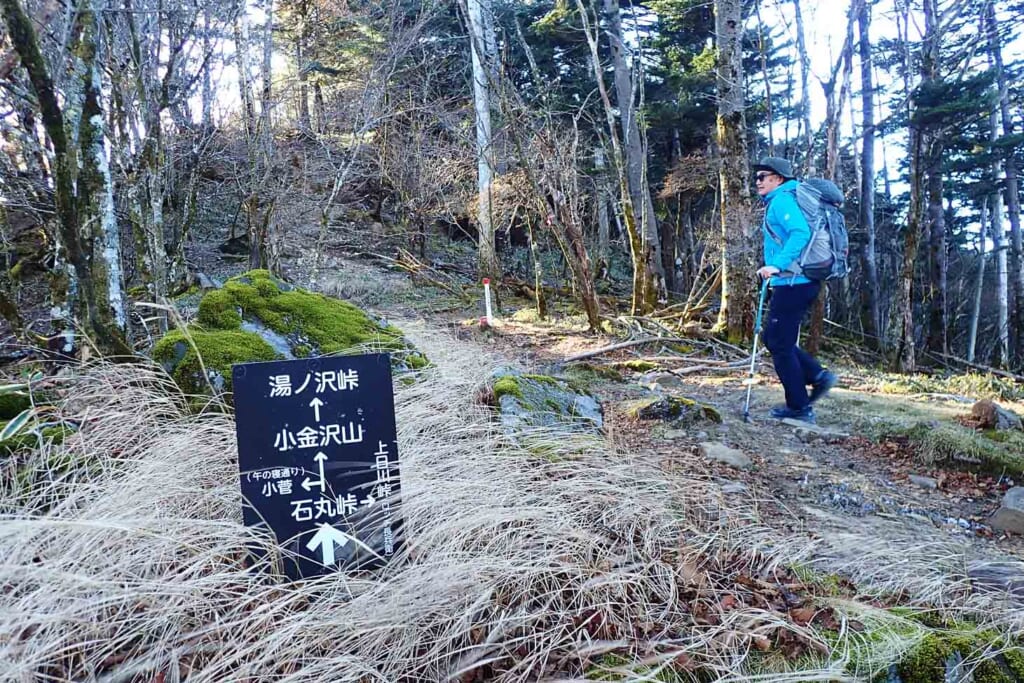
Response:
[468,0,501,282]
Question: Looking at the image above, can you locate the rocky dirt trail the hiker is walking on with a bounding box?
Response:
[184,235,1024,606]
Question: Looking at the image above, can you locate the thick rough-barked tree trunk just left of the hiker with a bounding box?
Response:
[715,0,757,342]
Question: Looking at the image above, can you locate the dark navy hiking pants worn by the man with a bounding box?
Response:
[761,282,821,411]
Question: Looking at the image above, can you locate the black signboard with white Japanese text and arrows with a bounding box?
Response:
[232,353,401,579]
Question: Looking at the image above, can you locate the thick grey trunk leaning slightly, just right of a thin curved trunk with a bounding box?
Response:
[604,0,666,309]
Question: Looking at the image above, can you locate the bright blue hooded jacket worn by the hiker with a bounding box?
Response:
[761,180,811,287]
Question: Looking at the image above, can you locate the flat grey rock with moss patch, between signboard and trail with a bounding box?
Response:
[490,370,603,430]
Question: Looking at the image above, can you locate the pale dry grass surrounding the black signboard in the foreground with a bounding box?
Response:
[6,327,1024,681]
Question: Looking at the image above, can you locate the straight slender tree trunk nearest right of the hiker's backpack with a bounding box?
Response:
[857,2,884,349]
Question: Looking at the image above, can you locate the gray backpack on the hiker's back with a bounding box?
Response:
[765,178,850,281]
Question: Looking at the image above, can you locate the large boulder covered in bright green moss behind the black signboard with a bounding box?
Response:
[153,270,429,393]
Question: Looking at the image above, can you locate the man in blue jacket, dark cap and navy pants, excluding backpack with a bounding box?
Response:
[754,157,839,423]
